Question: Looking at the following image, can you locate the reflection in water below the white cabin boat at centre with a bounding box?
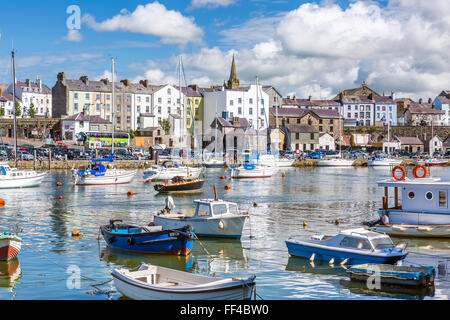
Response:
[191,238,250,276]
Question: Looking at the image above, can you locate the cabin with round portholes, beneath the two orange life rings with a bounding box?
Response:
[378,169,450,224]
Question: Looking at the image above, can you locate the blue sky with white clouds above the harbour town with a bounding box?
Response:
[0,0,450,98]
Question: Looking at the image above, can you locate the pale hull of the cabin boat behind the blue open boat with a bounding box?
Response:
[153,215,247,239]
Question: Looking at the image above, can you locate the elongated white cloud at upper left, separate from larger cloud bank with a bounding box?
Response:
[83,2,203,44]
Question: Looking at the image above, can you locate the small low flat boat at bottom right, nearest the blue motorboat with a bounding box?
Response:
[347,264,436,287]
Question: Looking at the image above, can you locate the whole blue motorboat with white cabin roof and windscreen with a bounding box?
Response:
[286,228,408,265]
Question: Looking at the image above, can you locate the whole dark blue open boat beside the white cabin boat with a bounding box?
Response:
[100,220,194,255]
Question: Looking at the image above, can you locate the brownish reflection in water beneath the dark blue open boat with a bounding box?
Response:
[100,247,194,271]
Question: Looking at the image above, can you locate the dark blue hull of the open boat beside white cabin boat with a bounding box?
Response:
[100,226,194,256]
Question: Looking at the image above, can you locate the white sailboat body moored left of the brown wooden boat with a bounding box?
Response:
[73,169,137,186]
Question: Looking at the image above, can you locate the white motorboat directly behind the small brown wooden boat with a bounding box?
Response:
[144,161,203,181]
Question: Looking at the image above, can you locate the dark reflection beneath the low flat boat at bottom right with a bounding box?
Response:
[339,279,435,300]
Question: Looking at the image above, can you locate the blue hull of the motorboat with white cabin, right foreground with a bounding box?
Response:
[286,240,406,265]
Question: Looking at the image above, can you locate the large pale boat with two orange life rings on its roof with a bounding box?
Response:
[367,165,450,238]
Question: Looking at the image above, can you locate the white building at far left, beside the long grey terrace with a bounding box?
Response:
[17,77,52,118]
